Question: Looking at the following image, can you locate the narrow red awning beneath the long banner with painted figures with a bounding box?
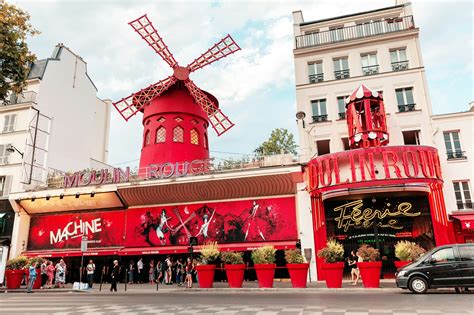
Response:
[119,241,296,256]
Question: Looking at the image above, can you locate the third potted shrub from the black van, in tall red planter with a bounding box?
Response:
[318,240,344,288]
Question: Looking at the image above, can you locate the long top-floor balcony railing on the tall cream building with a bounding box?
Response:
[295,15,415,49]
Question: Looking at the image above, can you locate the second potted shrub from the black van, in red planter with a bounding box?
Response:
[357,245,382,288]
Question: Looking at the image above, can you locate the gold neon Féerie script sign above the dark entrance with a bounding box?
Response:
[334,200,421,232]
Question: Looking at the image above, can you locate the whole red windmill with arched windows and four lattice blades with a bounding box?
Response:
[113,14,240,170]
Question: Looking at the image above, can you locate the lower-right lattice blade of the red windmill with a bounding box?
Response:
[184,80,234,136]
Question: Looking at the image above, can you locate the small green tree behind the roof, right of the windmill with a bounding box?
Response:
[254,128,297,155]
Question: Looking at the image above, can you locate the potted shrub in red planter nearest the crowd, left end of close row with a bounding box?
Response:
[196,242,220,288]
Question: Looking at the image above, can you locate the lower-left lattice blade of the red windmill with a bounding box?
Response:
[113,76,176,121]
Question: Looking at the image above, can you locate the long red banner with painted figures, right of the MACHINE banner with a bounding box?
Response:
[125,197,298,247]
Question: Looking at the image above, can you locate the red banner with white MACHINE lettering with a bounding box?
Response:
[28,211,125,250]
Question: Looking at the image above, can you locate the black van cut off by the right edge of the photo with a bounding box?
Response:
[395,244,474,293]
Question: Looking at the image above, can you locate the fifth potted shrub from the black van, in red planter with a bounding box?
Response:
[252,245,276,288]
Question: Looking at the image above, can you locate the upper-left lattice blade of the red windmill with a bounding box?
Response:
[128,14,178,68]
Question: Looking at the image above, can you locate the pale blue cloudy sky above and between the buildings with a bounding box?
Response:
[8,0,474,167]
